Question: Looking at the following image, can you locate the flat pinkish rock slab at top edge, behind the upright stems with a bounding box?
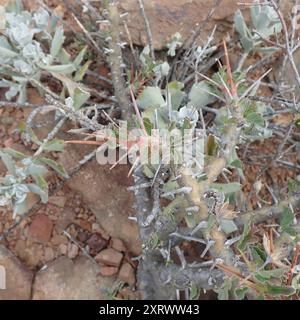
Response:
[119,0,241,50]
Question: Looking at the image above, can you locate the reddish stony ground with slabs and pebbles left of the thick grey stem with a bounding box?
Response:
[0,91,140,299]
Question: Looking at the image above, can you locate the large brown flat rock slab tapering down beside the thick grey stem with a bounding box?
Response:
[59,141,141,255]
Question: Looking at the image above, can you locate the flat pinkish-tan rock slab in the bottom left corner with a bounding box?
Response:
[0,245,33,300]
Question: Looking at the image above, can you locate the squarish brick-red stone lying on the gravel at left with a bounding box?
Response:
[28,213,53,243]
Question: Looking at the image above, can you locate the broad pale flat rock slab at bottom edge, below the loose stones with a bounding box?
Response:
[32,256,115,300]
